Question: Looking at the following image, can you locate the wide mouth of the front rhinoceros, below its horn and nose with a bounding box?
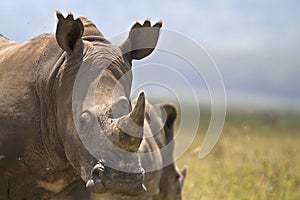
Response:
[86,163,146,196]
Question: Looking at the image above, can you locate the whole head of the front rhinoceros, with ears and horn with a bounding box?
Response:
[56,12,162,195]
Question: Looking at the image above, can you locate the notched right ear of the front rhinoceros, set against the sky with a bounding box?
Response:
[120,20,162,62]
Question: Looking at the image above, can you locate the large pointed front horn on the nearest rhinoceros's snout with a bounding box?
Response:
[117,92,145,152]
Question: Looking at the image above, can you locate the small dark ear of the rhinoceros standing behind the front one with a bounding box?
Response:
[160,104,177,143]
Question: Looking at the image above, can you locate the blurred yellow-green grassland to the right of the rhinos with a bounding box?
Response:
[177,109,300,200]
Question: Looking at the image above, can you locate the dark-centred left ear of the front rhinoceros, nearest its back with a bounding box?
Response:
[56,11,84,55]
